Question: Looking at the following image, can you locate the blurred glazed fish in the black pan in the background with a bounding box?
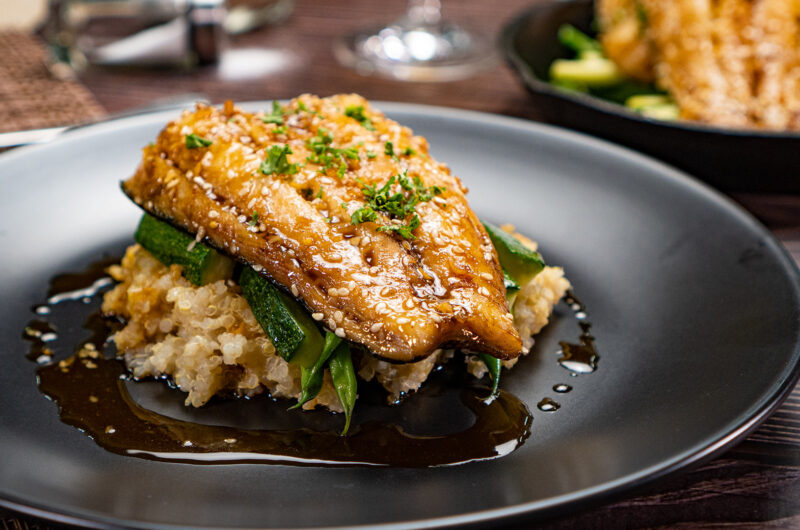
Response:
[596,0,800,130]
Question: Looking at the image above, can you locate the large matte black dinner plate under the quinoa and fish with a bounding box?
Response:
[0,104,800,528]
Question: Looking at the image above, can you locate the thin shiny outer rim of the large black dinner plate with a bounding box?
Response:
[0,100,800,530]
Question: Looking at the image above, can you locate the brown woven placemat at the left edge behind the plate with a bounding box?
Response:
[0,31,106,132]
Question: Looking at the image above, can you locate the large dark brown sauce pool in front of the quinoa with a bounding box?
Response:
[23,260,533,467]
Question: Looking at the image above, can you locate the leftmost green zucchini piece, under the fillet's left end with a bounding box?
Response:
[134,214,234,285]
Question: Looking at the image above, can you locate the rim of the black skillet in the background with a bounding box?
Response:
[498,0,800,140]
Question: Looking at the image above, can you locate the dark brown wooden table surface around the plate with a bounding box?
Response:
[0,0,800,529]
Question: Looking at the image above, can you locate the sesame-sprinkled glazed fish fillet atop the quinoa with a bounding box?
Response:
[122,95,522,362]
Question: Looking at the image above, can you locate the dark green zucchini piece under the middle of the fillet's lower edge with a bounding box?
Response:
[239,267,325,369]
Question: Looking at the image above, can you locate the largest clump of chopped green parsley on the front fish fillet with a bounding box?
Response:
[350,173,445,239]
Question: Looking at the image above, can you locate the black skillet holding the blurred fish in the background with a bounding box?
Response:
[501,0,800,192]
